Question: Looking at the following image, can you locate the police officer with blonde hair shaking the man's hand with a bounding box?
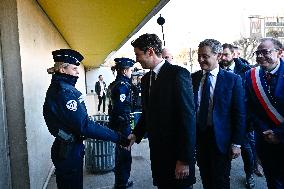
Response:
[43,49,129,189]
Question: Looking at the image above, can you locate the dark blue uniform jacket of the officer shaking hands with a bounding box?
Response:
[43,73,119,142]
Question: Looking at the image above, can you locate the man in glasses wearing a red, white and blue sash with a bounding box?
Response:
[245,38,284,189]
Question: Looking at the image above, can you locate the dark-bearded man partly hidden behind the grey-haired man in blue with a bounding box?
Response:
[219,43,257,189]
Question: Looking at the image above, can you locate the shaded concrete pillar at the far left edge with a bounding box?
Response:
[0,0,30,189]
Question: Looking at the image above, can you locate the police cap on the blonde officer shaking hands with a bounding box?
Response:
[52,49,84,66]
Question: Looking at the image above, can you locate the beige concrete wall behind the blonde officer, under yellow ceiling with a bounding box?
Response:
[17,0,86,189]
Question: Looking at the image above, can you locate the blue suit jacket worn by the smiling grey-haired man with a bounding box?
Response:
[192,68,246,154]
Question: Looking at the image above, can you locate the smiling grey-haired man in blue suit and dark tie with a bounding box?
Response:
[192,39,246,189]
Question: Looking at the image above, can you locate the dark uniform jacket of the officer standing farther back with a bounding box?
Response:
[110,75,132,135]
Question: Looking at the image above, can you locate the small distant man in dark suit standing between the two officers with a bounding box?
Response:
[95,75,106,113]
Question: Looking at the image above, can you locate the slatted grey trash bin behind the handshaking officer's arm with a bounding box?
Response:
[85,115,115,173]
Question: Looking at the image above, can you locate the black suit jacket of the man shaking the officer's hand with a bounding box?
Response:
[133,61,196,185]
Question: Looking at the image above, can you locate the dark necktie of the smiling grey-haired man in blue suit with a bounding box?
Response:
[199,72,210,130]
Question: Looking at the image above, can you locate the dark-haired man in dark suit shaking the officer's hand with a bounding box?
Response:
[129,34,196,189]
